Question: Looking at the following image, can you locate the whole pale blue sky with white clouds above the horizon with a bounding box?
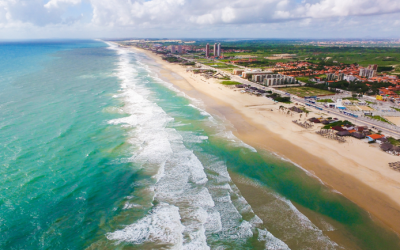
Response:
[0,0,400,40]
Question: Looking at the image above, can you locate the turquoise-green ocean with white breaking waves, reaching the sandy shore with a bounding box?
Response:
[0,40,400,250]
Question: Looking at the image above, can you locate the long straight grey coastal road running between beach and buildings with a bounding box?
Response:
[176,55,400,138]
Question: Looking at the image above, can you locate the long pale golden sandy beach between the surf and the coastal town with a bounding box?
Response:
[130,48,400,234]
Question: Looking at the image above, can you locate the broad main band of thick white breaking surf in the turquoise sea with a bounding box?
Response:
[107,47,214,249]
